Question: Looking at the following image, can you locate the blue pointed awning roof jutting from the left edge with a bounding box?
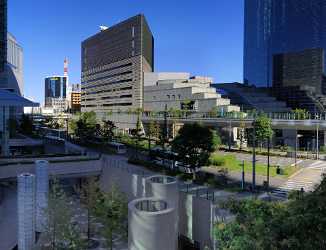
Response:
[0,89,40,107]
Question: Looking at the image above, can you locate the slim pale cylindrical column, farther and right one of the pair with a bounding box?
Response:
[35,160,49,232]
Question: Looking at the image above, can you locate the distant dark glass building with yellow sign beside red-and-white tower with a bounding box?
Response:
[45,76,67,106]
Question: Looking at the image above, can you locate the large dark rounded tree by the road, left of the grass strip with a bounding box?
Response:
[172,123,220,177]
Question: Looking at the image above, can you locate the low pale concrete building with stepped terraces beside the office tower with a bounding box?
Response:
[144,73,240,112]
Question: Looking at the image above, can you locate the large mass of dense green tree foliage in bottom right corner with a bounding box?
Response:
[215,176,326,250]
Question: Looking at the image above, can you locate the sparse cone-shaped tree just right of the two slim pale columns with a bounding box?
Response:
[44,181,85,250]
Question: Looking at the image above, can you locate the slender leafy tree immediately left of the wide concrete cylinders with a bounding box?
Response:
[97,184,128,250]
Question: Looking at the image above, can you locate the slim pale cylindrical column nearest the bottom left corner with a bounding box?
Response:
[17,174,35,250]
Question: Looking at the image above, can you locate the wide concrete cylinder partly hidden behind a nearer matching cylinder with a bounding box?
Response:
[145,175,179,247]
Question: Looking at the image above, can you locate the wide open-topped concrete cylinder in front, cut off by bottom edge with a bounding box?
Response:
[128,198,178,250]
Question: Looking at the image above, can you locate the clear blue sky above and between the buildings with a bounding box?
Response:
[8,0,244,101]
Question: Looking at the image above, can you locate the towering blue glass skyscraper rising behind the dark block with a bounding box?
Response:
[244,0,326,87]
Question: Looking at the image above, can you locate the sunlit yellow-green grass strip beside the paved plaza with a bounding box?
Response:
[210,153,299,178]
